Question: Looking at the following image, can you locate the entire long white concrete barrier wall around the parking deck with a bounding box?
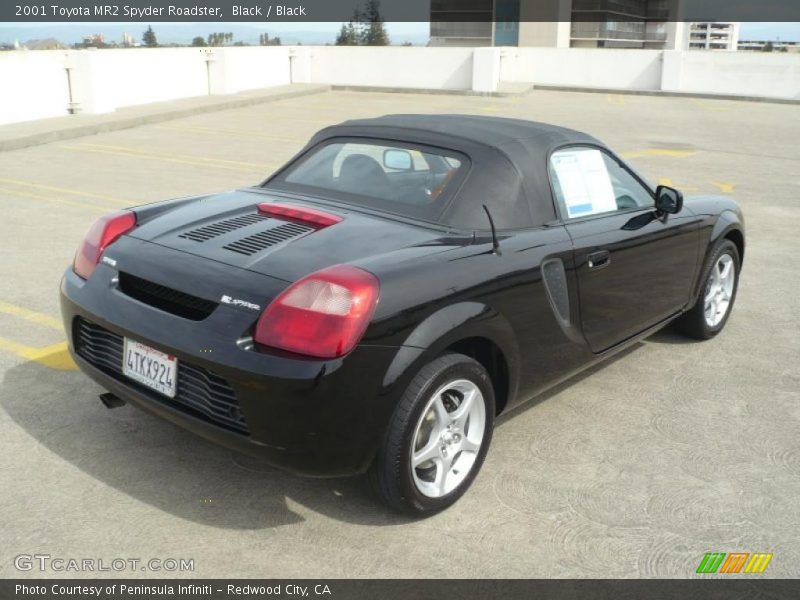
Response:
[0,46,800,124]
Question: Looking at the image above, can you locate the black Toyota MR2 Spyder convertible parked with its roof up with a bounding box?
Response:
[61,115,745,514]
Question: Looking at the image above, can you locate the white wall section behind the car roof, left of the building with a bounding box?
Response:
[310,46,473,90]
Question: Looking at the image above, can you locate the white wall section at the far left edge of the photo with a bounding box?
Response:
[0,50,69,124]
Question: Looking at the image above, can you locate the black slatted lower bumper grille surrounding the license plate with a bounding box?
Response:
[74,317,249,435]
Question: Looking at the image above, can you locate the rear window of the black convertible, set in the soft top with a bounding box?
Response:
[269,139,468,221]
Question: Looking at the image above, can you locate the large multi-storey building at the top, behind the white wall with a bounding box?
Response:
[430,0,686,50]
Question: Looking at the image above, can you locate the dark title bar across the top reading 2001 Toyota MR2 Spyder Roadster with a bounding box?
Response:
[0,0,800,23]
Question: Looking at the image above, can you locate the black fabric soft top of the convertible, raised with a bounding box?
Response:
[282,115,605,230]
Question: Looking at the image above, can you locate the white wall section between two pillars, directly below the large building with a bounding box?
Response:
[510,48,661,90]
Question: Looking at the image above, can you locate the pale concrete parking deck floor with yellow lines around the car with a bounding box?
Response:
[0,92,800,578]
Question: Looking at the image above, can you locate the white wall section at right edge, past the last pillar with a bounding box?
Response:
[680,51,800,99]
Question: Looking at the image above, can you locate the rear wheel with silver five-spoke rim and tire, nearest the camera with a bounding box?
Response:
[369,354,495,516]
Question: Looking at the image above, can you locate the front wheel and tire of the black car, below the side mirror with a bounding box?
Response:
[675,239,741,340]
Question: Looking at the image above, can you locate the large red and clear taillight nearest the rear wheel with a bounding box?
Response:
[253,265,380,358]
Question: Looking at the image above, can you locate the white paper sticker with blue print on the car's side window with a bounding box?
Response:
[551,148,617,219]
